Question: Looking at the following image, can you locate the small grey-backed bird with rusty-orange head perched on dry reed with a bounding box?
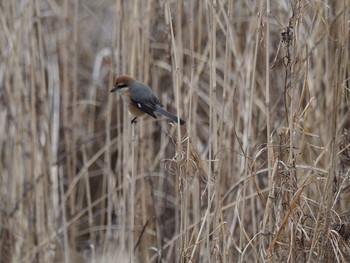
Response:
[110,75,186,125]
